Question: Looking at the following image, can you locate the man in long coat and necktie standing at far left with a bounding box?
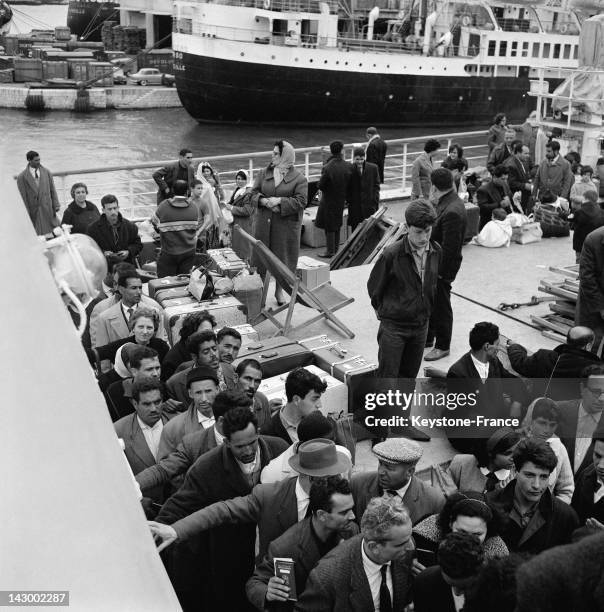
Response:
[17,151,61,236]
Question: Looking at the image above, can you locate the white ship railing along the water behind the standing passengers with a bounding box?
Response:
[41,131,488,219]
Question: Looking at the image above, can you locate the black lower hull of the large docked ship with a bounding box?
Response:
[175,53,555,127]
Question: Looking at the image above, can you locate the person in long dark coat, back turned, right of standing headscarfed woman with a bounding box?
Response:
[315,140,352,258]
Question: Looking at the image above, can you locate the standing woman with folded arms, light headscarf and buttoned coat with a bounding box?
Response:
[252,140,308,306]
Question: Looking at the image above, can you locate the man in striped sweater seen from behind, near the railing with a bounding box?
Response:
[151,181,203,278]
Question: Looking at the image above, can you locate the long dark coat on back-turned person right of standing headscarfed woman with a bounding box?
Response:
[315,155,352,232]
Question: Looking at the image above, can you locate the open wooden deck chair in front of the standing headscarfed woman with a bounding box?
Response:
[233,225,354,338]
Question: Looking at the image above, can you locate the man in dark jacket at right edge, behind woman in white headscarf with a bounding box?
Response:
[558,365,604,479]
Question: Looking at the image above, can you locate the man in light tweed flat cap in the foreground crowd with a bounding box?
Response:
[350,438,445,525]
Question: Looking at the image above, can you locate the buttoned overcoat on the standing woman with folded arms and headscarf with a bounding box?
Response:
[252,166,308,275]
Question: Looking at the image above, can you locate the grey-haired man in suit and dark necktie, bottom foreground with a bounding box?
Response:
[296,496,415,612]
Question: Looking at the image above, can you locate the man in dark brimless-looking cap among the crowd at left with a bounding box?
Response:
[158,366,218,459]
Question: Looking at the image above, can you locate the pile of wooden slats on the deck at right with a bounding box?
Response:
[531,264,579,342]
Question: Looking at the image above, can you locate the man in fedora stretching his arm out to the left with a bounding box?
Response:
[149,438,352,559]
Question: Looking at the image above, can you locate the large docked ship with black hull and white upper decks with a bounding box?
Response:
[173,0,580,126]
